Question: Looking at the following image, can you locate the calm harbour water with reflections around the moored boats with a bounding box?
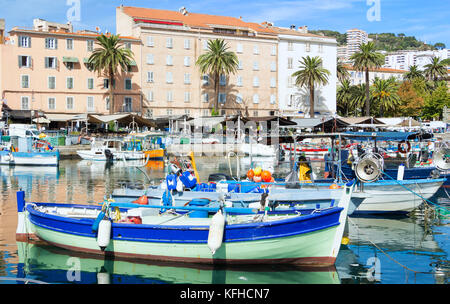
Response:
[0,158,450,284]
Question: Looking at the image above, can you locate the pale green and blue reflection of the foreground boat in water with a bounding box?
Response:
[17,242,340,284]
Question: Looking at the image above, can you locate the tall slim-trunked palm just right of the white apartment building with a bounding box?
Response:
[350,41,384,116]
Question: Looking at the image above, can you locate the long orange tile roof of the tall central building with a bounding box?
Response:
[119,6,275,34]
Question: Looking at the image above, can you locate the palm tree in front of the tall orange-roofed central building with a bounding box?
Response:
[196,39,239,111]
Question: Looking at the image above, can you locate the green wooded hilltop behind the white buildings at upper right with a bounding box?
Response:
[309,30,436,52]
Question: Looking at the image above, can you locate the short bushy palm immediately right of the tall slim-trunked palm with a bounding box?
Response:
[372,77,400,117]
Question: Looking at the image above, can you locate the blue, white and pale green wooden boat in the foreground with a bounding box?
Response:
[17,183,354,266]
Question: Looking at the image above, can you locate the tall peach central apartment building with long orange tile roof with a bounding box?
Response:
[116,6,278,117]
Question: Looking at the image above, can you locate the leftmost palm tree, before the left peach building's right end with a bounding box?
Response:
[88,34,134,114]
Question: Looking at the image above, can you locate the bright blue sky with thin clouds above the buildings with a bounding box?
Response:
[0,0,450,48]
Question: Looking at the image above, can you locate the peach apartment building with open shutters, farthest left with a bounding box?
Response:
[0,19,142,114]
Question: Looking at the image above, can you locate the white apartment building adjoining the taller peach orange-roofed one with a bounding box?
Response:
[271,26,337,116]
